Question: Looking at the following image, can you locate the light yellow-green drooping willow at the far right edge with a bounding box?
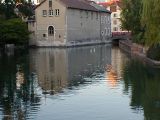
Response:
[142,0,160,46]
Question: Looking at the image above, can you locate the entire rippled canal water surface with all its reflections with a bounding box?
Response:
[0,45,160,120]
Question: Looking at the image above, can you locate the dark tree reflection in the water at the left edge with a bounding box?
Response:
[0,51,40,120]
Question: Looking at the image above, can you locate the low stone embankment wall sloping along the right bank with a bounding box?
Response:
[119,40,160,68]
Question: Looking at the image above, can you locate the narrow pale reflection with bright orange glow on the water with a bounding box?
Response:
[106,47,128,87]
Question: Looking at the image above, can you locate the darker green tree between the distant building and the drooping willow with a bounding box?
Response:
[121,0,144,44]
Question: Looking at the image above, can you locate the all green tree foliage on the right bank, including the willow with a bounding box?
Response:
[121,0,160,47]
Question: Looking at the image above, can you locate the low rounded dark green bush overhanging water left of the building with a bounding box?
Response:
[0,18,29,45]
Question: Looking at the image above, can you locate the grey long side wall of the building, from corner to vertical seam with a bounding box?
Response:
[67,9,100,43]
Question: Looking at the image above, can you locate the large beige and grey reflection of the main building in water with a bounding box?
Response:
[30,45,111,94]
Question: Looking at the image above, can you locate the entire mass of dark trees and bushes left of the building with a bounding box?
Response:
[0,0,34,45]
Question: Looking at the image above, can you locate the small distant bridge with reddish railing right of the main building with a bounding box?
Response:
[112,32,131,44]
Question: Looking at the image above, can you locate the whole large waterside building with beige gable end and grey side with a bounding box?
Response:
[28,0,111,46]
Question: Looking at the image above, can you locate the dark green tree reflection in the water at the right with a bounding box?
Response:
[124,60,160,120]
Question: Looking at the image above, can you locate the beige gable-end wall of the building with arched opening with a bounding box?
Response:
[31,0,66,46]
